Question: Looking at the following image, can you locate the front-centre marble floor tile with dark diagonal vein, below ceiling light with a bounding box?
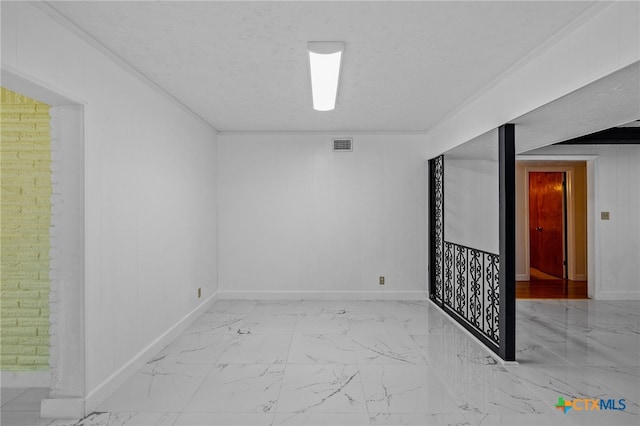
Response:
[276,364,367,414]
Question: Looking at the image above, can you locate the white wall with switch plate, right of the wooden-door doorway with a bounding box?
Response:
[521,145,640,300]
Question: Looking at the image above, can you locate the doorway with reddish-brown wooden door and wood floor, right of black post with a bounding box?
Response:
[516,160,588,299]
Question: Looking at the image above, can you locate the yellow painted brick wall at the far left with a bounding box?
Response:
[0,88,51,371]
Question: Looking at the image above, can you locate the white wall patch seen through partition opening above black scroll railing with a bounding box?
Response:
[444,158,500,254]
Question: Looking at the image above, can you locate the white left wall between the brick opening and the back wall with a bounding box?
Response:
[2,2,217,410]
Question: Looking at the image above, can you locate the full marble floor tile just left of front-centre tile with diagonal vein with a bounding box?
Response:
[184,364,284,414]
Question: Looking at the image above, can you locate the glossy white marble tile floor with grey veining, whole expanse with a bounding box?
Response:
[2,300,640,426]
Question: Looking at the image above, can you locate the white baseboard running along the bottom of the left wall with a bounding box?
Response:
[40,293,218,418]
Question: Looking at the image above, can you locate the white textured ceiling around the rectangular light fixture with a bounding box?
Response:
[50,1,593,131]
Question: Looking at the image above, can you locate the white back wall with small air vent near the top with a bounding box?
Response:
[218,134,427,298]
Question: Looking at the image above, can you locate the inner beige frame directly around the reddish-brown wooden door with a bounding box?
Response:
[524,166,568,281]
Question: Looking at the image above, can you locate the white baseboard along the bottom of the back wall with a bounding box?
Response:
[218,291,428,300]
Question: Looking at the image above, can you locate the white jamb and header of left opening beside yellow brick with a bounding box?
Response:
[0,64,87,417]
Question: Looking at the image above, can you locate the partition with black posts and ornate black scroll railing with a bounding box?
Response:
[429,124,515,361]
